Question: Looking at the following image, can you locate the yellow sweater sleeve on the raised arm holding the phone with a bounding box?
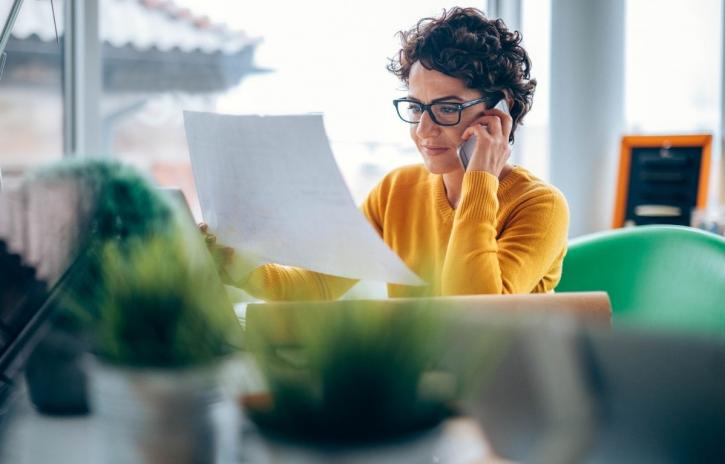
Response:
[441,171,569,295]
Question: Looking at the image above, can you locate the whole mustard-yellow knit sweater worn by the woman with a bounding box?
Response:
[241,165,569,300]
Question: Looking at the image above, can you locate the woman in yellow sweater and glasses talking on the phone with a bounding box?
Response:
[202,8,569,300]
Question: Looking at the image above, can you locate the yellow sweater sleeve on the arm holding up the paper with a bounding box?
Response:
[239,187,382,301]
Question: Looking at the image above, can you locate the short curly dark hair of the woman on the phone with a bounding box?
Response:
[388,7,536,142]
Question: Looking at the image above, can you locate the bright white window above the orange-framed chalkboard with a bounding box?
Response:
[625,0,723,133]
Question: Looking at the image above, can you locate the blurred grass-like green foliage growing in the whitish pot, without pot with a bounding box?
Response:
[95,234,242,368]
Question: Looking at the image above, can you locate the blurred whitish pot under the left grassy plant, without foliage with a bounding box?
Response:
[91,362,239,464]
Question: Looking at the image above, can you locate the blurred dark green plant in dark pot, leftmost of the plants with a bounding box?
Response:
[24,159,184,415]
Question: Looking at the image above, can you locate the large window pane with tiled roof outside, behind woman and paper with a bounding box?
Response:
[101,0,486,211]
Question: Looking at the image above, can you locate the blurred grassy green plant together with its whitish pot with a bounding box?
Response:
[86,234,242,463]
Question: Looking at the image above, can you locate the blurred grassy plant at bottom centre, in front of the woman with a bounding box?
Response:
[242,300,502,463]
